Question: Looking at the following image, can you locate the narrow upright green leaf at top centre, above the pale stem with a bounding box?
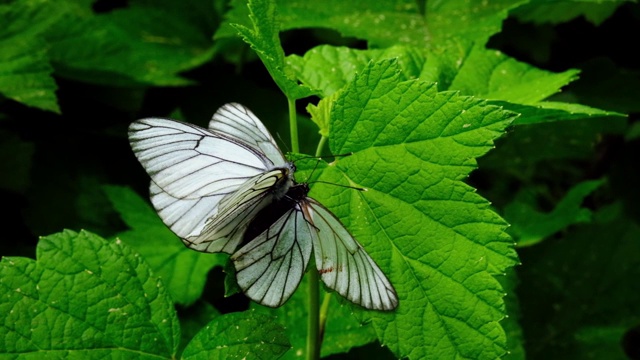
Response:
[233,0,313,100]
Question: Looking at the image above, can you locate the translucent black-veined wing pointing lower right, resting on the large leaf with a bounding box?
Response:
[308,198,398,310]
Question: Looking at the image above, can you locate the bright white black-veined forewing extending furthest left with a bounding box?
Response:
[129,118,272,200]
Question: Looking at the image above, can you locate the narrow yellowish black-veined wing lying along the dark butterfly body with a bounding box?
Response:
[183,169,289,254]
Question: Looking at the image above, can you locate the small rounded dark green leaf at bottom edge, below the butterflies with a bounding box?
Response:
[182,311,291,360]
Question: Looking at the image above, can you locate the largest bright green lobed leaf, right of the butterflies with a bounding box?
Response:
[302,60,517,359]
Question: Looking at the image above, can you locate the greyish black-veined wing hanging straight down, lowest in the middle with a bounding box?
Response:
[231,208,315,307]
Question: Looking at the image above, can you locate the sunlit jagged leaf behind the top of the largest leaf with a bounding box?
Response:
[287,44,624,131]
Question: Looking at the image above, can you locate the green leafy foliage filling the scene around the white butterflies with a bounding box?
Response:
[0,0,640,359]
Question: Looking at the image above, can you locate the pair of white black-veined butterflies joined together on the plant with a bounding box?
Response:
[129,104,398,310]
